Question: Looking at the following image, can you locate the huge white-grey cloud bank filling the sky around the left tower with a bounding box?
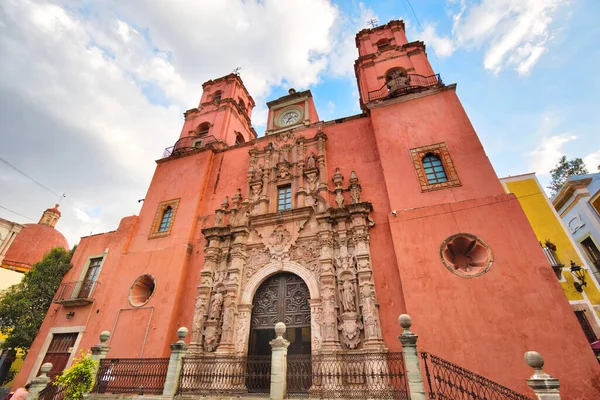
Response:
[0,0,339,245]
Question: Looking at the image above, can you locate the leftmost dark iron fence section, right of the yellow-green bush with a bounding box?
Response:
[92,358,169,394]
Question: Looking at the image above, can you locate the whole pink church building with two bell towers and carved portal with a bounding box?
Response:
[15,21,599,399]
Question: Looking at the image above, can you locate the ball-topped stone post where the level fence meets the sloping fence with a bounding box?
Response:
[398,314,426,400]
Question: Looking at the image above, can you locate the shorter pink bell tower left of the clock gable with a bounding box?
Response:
[179,73,257,147]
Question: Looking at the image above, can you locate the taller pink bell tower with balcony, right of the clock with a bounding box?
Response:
[354,20,439,110]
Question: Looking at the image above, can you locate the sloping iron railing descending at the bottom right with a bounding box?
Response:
[421,353,531,400]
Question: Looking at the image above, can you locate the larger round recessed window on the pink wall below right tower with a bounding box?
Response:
[440,233,494,278]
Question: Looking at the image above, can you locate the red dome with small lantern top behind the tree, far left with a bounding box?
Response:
[2,205,69,272]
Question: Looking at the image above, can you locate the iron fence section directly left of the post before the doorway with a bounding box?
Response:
[177,355,271,396]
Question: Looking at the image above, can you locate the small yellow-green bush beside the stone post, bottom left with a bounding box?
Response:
[54,351,98,400]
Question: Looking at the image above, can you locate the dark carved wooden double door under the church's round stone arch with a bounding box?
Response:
[248,272,311,355]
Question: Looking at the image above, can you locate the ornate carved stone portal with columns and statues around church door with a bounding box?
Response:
[190,131,384,355]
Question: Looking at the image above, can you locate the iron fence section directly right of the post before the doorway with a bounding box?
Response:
[308,353,409,399]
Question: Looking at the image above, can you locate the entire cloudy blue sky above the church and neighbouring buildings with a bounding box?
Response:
[0,0,600,245]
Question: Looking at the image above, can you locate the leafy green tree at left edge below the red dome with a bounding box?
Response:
[0,247,75,352]
